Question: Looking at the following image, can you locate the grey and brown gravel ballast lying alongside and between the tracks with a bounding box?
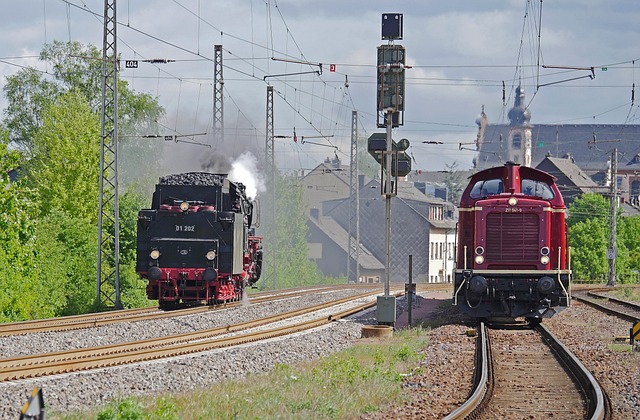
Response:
[0,290,640,419]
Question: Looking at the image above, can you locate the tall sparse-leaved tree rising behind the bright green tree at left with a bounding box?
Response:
[3,41,164,180]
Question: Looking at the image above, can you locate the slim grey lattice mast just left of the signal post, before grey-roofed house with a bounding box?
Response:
[347,111,360,283]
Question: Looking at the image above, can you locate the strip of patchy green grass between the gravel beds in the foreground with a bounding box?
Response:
[57,328,428,420]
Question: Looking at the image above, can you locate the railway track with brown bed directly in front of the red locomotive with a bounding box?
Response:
[446,323,611,419]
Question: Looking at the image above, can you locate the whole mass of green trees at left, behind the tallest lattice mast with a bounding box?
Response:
[0,41,164,321]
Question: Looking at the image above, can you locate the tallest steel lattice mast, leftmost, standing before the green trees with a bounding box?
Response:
[96,0,122,309]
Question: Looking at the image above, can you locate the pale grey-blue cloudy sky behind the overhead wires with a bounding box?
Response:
[0,0,640,170]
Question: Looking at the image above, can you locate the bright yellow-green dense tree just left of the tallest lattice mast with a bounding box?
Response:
[22,90,100,315]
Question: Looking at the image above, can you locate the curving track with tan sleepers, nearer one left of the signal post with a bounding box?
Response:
[0,290,402,381]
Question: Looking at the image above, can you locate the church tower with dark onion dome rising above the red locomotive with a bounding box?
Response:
[504,83,531,166]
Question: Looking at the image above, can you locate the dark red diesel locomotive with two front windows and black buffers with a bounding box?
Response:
[453,162,571,322]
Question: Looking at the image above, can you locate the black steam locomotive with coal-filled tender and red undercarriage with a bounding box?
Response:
[136,172,262,308]
